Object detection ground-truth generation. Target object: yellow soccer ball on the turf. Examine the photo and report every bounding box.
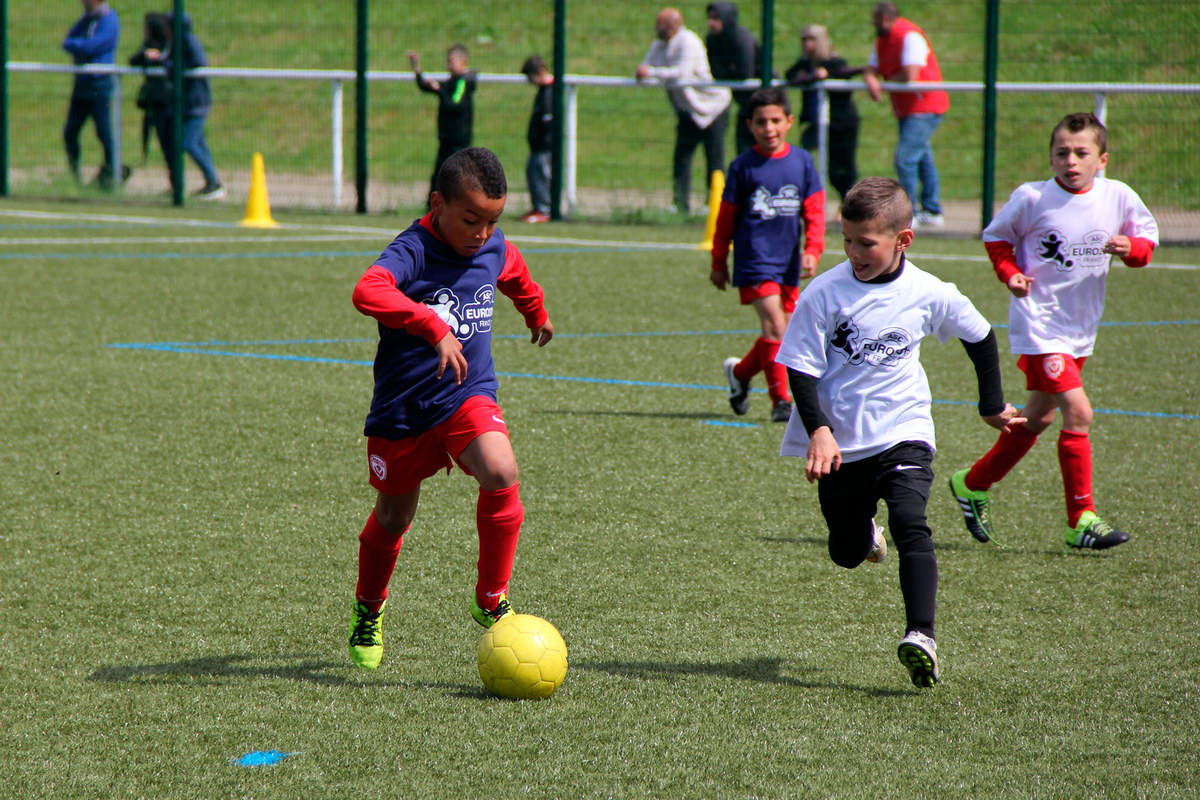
[475,614,566,700]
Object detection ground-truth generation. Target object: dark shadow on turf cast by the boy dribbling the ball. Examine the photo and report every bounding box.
[88,655,477,697]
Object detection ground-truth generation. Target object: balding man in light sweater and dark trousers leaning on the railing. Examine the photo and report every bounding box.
[634,7,730,213]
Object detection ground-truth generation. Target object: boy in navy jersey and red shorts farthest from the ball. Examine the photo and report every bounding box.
[709,86,826,422]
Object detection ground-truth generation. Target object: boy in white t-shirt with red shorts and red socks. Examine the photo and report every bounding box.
[950,113,1158,549]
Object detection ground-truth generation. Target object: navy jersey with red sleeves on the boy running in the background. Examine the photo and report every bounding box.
[721,145,824,287]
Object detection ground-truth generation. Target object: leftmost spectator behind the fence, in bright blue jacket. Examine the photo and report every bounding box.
[62,0,128,188]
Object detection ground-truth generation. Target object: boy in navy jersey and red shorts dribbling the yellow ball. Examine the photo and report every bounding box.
[349,148,554,669]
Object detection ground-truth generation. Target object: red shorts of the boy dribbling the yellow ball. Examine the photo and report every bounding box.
[367,396,509,494]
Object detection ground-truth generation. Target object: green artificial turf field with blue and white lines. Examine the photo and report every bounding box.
[0,201,1200,799]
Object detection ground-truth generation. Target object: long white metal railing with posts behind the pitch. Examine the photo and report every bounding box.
[8,61,1200,213]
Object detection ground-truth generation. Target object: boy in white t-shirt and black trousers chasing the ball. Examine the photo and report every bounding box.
[775,178,1024,687]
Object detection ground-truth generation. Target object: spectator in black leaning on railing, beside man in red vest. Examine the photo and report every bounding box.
[784,25,862,206]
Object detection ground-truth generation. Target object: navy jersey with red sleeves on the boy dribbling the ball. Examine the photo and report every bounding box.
[354,215,546,439]
